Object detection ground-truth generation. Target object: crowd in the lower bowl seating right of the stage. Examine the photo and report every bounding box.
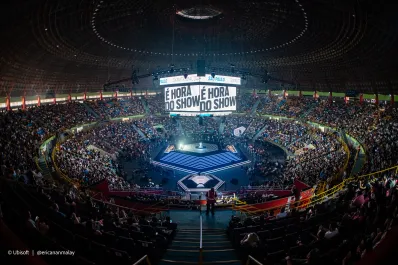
[236,118,347,187]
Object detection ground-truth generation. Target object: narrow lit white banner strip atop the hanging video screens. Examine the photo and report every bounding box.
[159,74,241,86]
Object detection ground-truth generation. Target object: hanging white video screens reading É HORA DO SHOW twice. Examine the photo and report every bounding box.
[164,85,236,112]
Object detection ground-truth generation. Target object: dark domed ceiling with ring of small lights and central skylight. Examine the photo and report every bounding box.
[0,0,398,95]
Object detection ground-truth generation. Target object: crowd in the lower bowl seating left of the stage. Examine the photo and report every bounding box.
[56,120,160,190]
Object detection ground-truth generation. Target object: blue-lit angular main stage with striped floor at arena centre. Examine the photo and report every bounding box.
[152,143,250,173]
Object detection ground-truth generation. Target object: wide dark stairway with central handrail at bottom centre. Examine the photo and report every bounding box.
[159,228,241,265]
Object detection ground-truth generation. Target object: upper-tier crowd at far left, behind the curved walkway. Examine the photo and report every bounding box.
[0,102,94,183]
